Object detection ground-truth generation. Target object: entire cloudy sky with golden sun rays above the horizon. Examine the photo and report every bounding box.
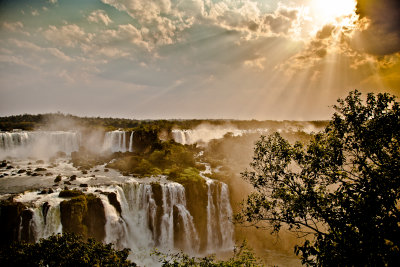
[0,0,400,120]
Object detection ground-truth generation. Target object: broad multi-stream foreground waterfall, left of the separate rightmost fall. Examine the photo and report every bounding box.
[101,183,199,253]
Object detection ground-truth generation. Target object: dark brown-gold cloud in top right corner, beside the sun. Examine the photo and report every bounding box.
[353,0,400,56]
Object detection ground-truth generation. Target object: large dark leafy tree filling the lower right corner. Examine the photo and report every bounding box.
[237,90,400,266]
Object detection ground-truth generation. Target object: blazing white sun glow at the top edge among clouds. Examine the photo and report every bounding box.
[310,0,357,24]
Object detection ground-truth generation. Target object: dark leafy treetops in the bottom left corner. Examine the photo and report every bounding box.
[0,233,136,266]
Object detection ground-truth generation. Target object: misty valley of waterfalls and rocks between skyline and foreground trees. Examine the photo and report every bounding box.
[0,114,326,266]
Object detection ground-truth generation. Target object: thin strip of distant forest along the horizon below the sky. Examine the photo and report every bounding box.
[0,113,327,131]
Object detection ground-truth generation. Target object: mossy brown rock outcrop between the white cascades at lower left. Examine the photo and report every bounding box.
[60,194,106,241]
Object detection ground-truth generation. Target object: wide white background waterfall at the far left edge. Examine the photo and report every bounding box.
[0,131,80,157]
